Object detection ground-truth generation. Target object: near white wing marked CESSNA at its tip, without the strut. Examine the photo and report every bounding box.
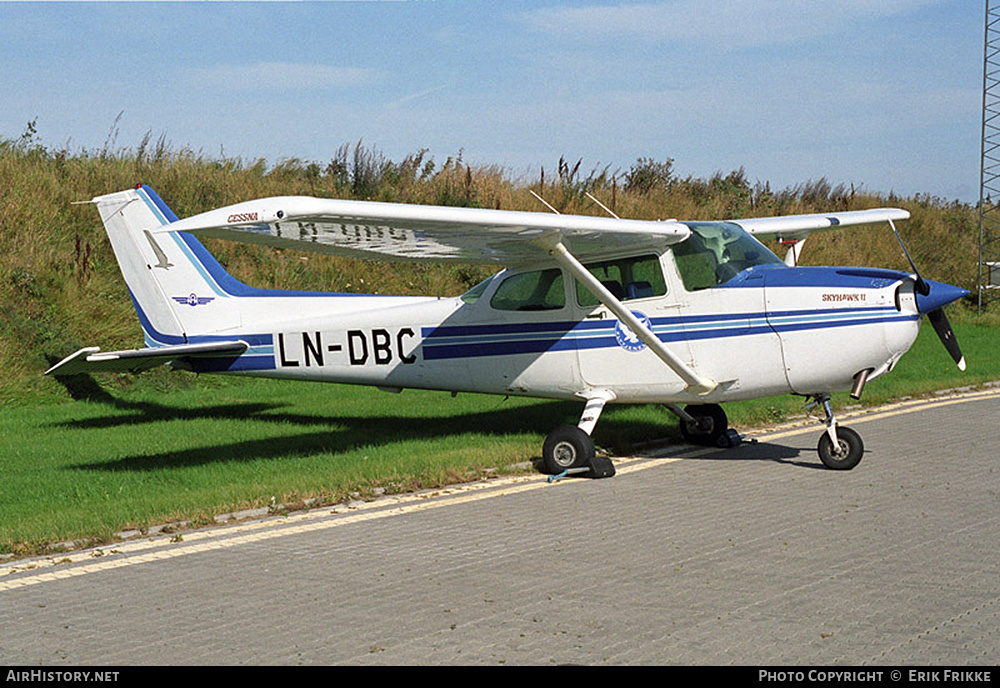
[156,196,690,265]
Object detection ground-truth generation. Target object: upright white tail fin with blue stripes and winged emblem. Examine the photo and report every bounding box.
[94,186,247,347]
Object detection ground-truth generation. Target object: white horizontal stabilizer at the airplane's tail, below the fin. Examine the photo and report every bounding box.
[45,341,249,375]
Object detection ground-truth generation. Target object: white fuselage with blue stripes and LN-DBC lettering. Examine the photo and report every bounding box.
[180,252,920,403]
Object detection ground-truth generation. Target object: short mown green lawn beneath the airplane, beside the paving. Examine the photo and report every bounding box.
[0,317,1000,554]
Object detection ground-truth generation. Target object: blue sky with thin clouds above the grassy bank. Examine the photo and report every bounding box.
[0,0,984,201]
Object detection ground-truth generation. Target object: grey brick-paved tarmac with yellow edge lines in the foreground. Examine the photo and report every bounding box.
[0,391,1000,666]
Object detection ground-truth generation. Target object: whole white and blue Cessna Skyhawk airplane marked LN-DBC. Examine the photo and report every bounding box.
[47,185,968,477]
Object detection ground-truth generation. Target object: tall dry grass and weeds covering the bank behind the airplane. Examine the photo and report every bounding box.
[0,129,977,404]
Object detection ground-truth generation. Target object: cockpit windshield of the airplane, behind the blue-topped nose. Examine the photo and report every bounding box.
[673,222,784,291]
